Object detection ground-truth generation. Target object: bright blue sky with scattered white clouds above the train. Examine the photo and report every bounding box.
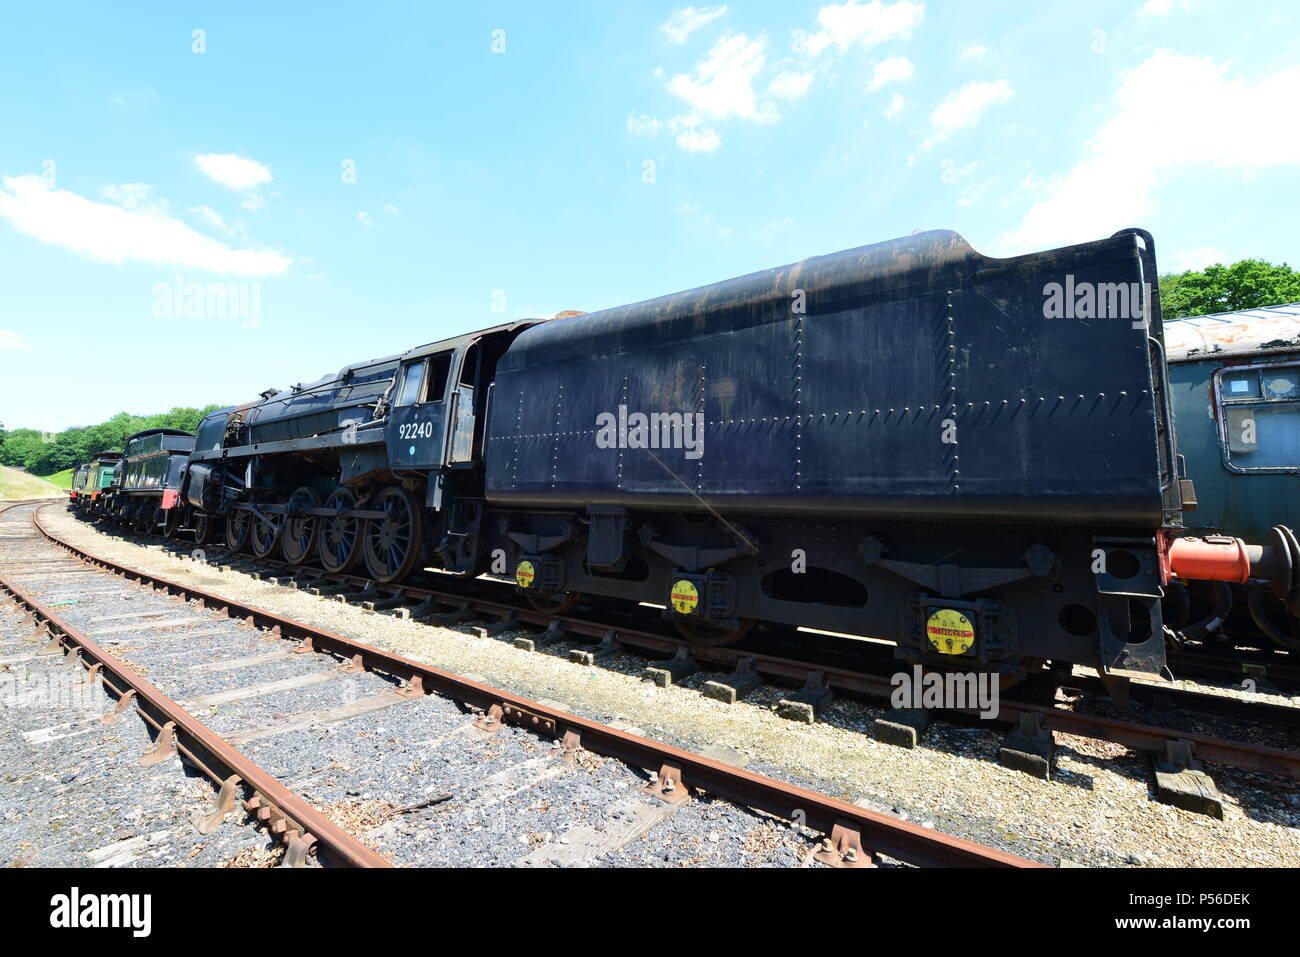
[0,0,1300,430]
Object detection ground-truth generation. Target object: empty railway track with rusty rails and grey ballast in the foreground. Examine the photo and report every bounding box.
[0,505,1032,866]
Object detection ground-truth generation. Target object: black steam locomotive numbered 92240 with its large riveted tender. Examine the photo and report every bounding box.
[76,230,1300,677]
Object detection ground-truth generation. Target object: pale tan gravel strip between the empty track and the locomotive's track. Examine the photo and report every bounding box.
[17,508,1300,867]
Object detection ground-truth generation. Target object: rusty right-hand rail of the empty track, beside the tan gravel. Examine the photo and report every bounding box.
[33,501,1044,867]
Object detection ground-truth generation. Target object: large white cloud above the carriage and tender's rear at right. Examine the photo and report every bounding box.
[1001,49,1300,251]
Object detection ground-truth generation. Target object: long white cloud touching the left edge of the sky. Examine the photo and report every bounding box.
[0,176,293,276]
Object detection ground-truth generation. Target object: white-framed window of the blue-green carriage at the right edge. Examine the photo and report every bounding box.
[1218,365,1300,472]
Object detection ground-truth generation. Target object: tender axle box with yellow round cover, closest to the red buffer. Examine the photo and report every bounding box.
[897,594,1019,663]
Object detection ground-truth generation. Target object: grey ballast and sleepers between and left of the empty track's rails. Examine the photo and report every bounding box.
[0,512,816,866]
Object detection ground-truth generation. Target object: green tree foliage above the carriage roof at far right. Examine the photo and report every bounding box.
[1160,259,1300,319]
